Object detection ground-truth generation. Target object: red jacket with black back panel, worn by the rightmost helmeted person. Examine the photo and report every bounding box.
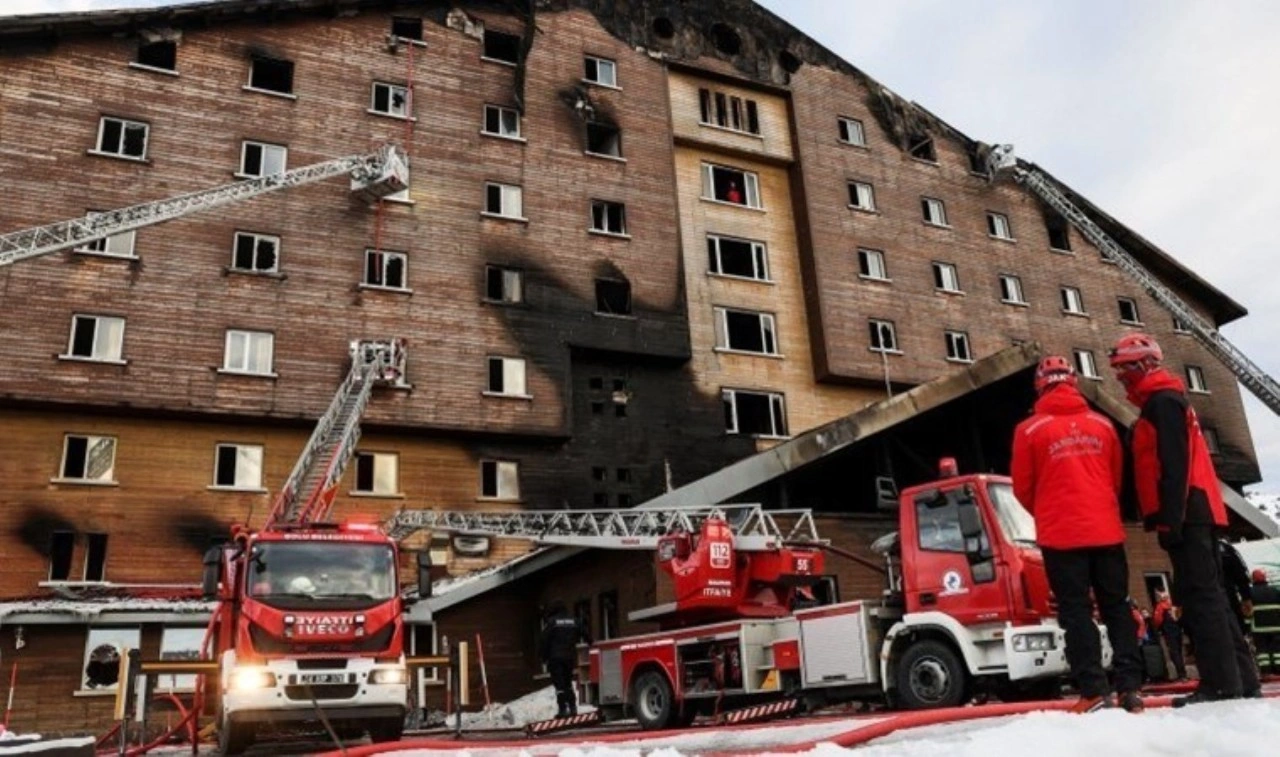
[1129,369,1226,534]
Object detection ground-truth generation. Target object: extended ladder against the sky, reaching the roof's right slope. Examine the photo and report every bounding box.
[987,145,1280,415]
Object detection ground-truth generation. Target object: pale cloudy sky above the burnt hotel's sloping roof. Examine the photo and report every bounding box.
[0,0,1280,492]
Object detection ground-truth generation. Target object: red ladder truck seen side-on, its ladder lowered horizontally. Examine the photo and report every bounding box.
[383,460,1095,730]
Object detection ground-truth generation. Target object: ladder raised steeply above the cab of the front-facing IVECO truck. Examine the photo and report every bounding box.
[266,339,404,529]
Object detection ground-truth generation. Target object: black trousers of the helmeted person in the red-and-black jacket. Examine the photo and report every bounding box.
[1167,523,1261,697]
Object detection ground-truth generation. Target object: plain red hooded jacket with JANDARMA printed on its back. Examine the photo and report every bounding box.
[1012,384,1124,549]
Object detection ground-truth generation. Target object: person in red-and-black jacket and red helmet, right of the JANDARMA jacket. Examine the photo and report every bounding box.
[1110,334,1261,707]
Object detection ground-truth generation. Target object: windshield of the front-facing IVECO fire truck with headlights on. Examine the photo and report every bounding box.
[248,542,396,608]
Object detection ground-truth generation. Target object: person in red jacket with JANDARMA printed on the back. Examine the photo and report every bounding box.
[1011,355,1142,712]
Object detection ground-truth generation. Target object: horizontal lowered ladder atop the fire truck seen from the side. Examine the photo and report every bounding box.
[383,505,823,552]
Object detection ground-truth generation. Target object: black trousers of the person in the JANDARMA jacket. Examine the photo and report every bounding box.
[1041,544,1143,697]
